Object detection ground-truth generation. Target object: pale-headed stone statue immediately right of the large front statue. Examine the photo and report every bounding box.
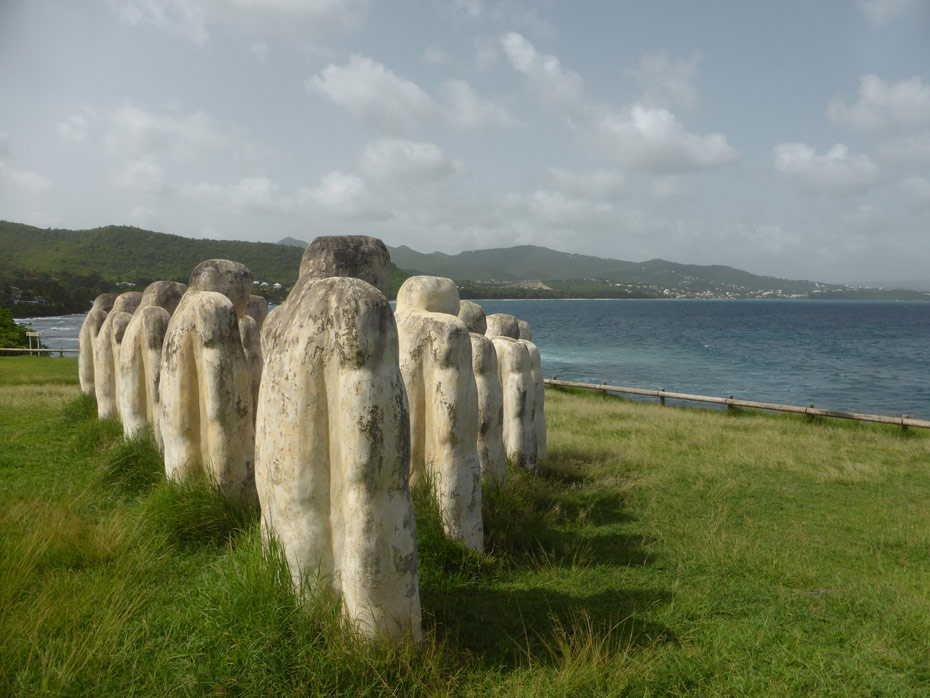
[394,276,484,550]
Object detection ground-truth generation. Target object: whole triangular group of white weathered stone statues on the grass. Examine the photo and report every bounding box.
[79,236,546,639]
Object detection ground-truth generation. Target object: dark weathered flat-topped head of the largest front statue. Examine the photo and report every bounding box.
[300,235,391,293]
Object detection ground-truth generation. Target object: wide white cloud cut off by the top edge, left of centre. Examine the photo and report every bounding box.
[108,0,370,45]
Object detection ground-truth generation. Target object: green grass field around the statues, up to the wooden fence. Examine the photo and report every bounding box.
[0,357,930,696]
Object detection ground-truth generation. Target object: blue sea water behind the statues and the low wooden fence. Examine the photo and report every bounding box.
[18,300,930,419]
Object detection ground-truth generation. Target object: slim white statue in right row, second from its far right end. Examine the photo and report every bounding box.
[487,314,539,472]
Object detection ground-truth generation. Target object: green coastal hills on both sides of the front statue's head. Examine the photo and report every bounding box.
[0,221,930,317]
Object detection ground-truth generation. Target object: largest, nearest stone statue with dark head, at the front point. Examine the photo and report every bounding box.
[255,236,421,640]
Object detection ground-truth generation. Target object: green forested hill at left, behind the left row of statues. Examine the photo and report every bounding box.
[0,221,303,286]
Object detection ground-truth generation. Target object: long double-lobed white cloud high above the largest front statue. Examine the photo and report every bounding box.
[306,54,516,135]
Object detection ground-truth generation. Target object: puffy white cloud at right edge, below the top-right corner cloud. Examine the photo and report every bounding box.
[827,75,930,131]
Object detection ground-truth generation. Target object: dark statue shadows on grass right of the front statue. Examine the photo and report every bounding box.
[421,454,676,669]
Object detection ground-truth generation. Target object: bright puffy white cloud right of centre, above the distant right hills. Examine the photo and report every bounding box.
[578,104,737,174]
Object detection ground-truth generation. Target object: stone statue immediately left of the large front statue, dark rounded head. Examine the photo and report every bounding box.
[158,259,255,501]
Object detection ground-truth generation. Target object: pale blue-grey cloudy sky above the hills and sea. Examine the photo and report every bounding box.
[0,0,930,283]
